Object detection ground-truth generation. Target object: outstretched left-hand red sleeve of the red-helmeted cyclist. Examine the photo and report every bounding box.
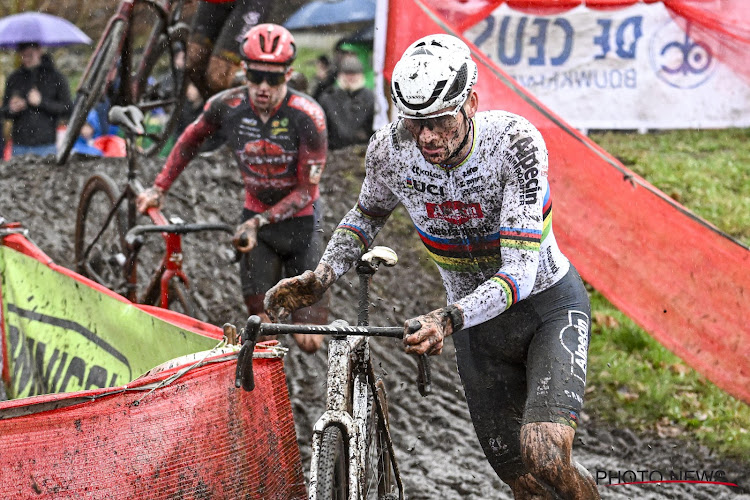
[154,100,220,192]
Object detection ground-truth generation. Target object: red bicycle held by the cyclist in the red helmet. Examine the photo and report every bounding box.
[74,106,236,317]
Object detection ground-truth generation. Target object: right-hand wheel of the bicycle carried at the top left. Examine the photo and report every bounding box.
[128,2,187,156]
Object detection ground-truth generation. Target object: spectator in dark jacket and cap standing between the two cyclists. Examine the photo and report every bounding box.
[318,55,375,149]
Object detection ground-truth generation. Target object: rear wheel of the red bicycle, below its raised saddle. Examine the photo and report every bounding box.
[74,174,127,294]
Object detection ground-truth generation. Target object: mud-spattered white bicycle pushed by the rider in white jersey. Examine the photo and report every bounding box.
[235,246,430,500]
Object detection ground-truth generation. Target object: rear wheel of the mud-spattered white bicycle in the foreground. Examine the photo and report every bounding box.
[362,380,398,500]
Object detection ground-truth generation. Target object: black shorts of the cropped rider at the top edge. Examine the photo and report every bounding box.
[190,0,271,64]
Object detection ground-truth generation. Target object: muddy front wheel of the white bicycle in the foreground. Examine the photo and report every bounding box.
[315,426,349,500]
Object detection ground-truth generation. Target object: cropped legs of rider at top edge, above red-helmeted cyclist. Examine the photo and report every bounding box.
[186,0,271,99]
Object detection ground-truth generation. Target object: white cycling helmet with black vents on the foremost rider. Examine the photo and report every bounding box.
[391,34,477,119]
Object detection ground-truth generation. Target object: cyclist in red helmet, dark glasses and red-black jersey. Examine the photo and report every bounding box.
[137,24,328,352]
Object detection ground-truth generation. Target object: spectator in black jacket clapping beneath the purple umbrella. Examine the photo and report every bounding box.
[2,43,72,156]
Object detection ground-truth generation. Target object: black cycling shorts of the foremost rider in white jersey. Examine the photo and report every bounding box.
[453,266,591,479]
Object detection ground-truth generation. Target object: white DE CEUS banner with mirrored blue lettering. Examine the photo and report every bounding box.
[464,2,750,131]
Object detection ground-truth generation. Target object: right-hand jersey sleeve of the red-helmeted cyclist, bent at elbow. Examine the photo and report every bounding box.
[266,95,328,222]
